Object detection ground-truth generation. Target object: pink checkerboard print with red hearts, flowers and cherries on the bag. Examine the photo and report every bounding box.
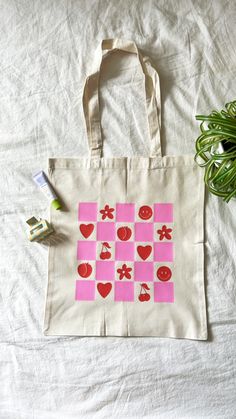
[75,202,174,303]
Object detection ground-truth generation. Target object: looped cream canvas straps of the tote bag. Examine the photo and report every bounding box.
[83,39,161,157]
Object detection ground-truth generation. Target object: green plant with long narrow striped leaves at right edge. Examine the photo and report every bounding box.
[195,101,236,202]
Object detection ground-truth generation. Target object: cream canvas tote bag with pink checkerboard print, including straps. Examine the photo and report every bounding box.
[43,39,207,340]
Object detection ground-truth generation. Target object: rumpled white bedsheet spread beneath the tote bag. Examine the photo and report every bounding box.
[0,0,236,419]
